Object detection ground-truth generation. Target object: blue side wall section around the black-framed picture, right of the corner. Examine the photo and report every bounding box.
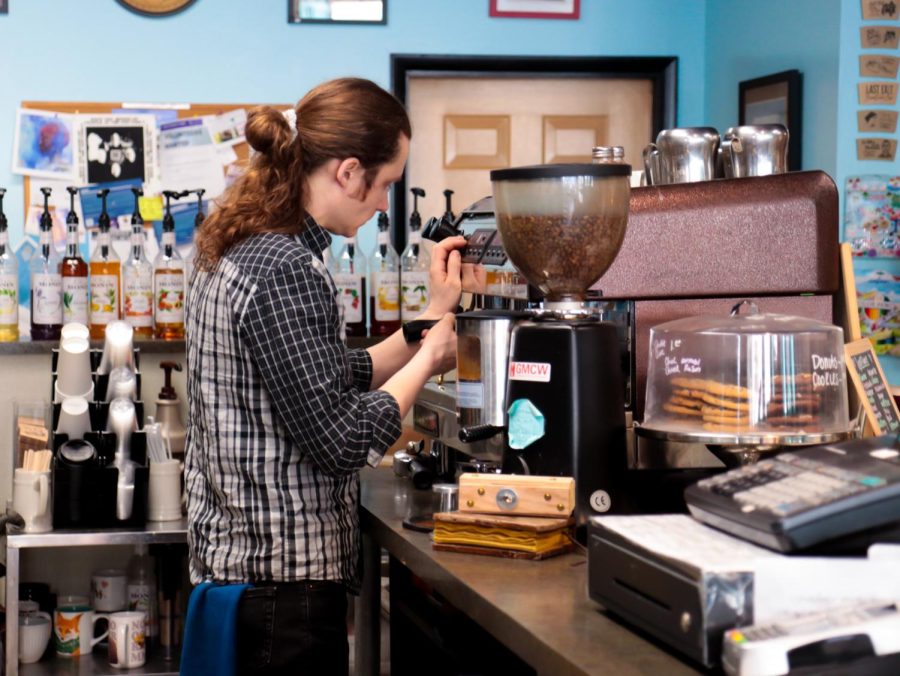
[706,0,844,176]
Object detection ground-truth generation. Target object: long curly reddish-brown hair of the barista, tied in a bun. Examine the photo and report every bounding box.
[195,78,412,270]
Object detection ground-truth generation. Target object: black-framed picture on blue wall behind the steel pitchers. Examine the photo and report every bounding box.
[738,70,803,171]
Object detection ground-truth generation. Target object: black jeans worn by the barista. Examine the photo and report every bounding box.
[237,581,349,676]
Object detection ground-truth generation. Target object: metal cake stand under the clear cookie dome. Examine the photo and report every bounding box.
[634,423,850,467]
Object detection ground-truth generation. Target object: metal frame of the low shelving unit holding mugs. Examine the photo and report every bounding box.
[6,519,187,676]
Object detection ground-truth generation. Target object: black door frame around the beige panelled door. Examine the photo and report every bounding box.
[391,54,678,251]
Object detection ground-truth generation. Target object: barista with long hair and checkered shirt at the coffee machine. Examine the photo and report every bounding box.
[185,78,464,674]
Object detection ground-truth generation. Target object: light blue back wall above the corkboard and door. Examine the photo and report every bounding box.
[0,0,706,251]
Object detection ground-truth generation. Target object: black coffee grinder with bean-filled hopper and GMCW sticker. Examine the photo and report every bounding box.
[457,164,631,527]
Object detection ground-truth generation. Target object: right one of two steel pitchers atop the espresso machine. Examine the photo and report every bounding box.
[722,124,790,178]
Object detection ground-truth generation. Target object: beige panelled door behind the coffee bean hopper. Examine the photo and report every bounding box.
[407,77,652,220]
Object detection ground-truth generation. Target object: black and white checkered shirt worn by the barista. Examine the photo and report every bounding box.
[185,219,400,589]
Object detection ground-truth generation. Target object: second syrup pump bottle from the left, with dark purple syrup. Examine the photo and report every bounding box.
[31,188,62,340]
